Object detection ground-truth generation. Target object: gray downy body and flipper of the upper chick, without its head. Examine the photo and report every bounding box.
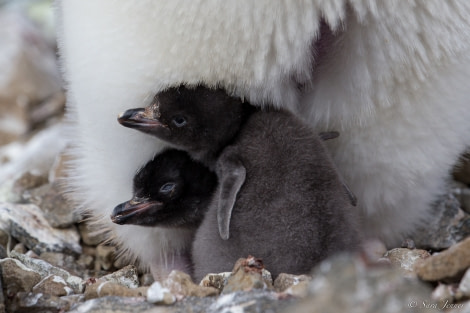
[193,112,359,279]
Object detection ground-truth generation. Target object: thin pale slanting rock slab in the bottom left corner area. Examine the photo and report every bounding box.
[11,252,85,294]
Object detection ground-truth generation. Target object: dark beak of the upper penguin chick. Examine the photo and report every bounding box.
[118,108,169,136]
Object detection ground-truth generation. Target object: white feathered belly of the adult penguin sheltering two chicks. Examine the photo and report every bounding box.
[57,0,470,276]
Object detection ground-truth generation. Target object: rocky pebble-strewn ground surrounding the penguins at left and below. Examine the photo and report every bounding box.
[0,1,470,313]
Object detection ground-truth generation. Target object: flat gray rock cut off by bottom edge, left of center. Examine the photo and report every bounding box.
[69,296,155,313]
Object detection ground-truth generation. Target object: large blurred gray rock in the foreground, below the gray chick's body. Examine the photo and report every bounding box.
[283,254,432,313]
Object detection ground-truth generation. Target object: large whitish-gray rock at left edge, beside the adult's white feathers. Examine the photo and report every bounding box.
[0,203,82,254]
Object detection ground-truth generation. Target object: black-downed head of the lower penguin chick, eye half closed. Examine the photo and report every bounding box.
[111,149,217,229]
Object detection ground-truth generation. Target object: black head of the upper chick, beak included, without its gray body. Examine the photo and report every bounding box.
[118,85,255,169]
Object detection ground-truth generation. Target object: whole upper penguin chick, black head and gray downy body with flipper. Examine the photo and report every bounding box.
[116,86,360,280]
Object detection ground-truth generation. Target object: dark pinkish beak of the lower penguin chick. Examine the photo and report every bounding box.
[111,199,163,226]
